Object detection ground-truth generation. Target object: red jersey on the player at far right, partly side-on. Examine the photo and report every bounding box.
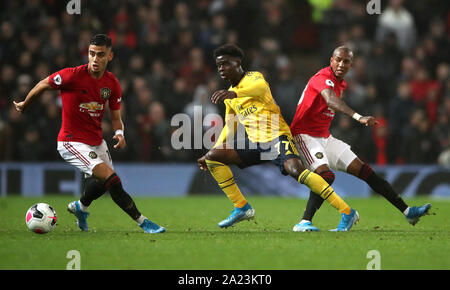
[291,67,347,137]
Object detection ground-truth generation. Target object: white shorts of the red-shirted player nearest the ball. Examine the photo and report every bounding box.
[58,140,114,177]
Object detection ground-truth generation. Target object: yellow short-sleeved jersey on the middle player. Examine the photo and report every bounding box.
[215,71,292,147]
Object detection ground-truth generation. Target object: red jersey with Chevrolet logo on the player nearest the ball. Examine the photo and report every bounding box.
[49,64,122,146]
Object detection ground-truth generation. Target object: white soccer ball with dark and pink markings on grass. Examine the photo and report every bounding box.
[25,202,57,234]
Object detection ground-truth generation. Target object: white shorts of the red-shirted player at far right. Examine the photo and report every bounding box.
[294,134,357,171]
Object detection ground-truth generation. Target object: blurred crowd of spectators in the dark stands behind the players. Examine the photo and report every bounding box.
[0,0,450,165]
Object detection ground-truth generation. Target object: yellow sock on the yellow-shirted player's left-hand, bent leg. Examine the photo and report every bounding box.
[206,159,247,208]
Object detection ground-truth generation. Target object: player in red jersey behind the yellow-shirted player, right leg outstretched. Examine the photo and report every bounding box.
[290,46,431,232]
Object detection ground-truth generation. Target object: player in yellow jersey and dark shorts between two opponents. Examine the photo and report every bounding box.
[198,44,359,231]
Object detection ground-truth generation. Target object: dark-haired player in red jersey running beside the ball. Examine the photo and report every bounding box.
[14,34,165,233]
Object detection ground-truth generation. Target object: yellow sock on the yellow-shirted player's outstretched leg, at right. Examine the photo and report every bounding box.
[298,169,351,214]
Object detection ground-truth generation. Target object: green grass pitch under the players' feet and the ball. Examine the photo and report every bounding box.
[0,195,450,270]
